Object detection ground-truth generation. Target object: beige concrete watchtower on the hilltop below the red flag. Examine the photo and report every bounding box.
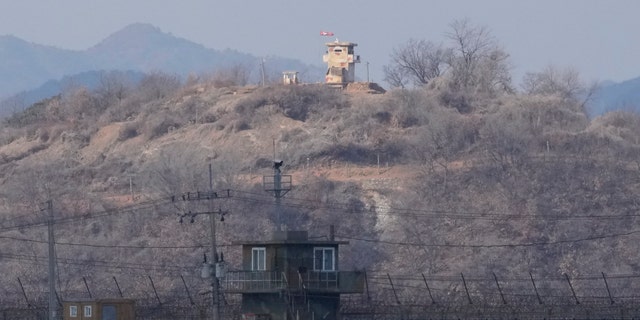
[322,40,360,86]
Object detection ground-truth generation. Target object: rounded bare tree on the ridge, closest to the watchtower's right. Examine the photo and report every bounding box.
[384,39,450,87]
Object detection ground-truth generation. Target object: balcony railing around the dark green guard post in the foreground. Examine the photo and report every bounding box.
[220,271,364,293]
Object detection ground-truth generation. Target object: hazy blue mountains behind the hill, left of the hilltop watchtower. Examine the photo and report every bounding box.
[0,23,325,111]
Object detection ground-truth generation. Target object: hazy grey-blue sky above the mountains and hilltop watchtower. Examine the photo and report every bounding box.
[0,0,640,83]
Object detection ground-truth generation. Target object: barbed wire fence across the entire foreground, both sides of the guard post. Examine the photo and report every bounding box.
[0,272,640,320]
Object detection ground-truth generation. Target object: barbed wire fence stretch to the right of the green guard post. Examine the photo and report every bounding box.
[342,273,640,320]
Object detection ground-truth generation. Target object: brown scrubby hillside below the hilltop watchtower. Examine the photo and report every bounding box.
[0,83,640,304]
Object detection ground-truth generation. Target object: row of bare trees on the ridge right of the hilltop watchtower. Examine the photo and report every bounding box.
[384,19,598,111]
